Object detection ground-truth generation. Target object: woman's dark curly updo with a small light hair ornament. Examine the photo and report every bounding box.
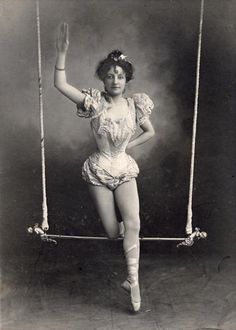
[96,50,134,82]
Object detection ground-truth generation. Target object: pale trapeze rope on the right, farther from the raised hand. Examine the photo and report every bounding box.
[185,0,204,234]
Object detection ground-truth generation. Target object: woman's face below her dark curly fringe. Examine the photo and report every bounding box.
[104,65,126,96]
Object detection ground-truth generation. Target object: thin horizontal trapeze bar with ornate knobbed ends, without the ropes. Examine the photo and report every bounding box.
[27,224,207,247]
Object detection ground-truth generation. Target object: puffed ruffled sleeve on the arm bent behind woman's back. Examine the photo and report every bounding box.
[133,93,154,125]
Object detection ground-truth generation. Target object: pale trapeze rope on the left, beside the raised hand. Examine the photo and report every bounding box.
[36,0,48,230]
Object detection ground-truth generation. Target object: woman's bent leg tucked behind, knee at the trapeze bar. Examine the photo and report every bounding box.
[89,184,119,238]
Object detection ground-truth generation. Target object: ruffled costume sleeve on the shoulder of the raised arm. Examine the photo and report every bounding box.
[76,88,101,118]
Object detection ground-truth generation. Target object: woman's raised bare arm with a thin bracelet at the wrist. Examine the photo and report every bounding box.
[54,23,85,106]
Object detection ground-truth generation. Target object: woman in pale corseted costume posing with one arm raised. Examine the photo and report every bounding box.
[54,23,155,312]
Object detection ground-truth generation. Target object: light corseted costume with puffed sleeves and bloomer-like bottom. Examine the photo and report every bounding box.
[77,88,154,190]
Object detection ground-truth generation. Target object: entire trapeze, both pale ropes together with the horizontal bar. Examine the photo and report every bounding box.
[27,0,207,247]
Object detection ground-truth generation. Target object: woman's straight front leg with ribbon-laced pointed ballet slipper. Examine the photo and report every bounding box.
[114,179,141,311]
